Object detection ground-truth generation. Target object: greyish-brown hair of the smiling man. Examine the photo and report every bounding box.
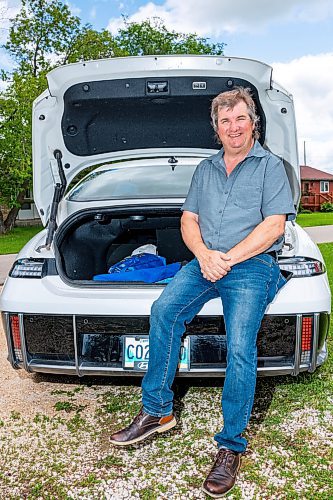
[211,87,260,142]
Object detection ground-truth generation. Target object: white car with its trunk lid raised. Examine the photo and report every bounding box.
[0,56,331,376]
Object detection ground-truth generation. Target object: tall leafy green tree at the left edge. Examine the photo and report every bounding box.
[0,0,83,234]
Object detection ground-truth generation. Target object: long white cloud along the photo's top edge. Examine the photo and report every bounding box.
[108,0,333,36]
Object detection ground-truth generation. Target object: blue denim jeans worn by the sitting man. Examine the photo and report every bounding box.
[142,254,286,452]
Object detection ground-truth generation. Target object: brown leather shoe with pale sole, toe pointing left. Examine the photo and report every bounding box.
[110,409,177,446]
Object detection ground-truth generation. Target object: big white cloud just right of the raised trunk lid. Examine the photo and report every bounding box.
[272,52,333,173]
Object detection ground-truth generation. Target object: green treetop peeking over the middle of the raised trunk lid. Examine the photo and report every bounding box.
[115,17,225,56]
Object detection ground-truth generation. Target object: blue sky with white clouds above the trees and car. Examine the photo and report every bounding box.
[0,0,333,174]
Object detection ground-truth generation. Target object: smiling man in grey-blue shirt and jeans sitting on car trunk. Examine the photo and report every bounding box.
[111,88,295,498]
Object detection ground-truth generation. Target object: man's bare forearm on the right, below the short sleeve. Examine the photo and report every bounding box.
[227,216,285,266]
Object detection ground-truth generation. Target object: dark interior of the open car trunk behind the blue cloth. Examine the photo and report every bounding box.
[55,207,193,286]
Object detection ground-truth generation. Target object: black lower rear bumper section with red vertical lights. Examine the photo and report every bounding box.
[3,312,329,377]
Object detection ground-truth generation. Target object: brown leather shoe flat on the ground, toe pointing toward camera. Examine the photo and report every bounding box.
[202,448,241,498]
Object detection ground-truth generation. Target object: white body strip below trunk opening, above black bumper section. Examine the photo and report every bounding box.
[1,275,330,316]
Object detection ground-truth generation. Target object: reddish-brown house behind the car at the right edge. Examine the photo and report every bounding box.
[301,166,333,212]
